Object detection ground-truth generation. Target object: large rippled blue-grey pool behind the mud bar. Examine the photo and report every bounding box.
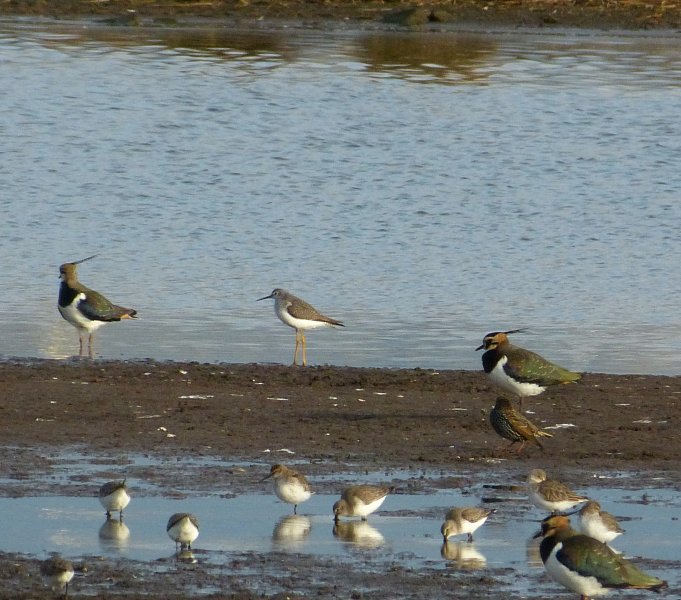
[0,22,681,374]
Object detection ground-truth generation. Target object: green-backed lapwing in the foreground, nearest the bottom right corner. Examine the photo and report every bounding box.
[537,515,667,600]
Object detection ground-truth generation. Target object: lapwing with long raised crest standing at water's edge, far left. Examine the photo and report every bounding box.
[58,255,137,358]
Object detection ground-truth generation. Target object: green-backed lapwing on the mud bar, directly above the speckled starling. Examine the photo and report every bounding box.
[476,329,582,410]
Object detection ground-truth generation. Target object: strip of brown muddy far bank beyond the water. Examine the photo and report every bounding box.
[0,0,681,31]
